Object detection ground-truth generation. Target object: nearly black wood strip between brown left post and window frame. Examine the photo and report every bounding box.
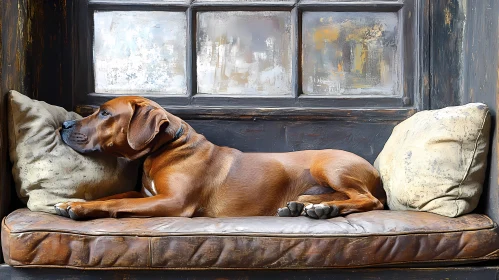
[26,0,73,109]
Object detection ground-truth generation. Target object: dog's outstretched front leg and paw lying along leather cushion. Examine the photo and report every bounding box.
[55,195,195,220]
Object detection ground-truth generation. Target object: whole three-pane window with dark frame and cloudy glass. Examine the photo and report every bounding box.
[75,0,427,118]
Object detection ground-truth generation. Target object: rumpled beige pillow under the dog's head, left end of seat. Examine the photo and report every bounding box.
[8,91,138,213]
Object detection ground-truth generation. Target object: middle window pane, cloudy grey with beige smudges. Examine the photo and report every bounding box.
[197,11,292,95]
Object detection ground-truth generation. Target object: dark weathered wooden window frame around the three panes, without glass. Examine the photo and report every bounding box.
[73,0,429,120]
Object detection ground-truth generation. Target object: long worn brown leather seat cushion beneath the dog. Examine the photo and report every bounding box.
[2,209,499,269]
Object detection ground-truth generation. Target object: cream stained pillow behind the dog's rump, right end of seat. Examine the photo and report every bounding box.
[374,103,490,217]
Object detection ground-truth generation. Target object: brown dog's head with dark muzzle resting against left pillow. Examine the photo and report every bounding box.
[61,96,181,159]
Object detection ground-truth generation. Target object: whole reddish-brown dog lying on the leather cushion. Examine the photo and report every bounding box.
[55,96,385,219]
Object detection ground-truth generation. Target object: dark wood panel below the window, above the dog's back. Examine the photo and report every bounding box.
[186,120,398,163]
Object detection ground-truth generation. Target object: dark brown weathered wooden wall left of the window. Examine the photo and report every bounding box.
[0,0,72,230]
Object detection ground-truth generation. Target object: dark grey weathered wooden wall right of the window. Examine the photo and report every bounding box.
[430,0,499,222]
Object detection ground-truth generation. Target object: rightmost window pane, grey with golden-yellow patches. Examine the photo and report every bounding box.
[302,12,400,96]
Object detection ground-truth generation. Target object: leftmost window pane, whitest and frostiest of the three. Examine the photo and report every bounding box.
[94,11,187,94]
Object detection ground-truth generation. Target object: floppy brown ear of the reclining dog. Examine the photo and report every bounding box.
[127,102,168,151]
